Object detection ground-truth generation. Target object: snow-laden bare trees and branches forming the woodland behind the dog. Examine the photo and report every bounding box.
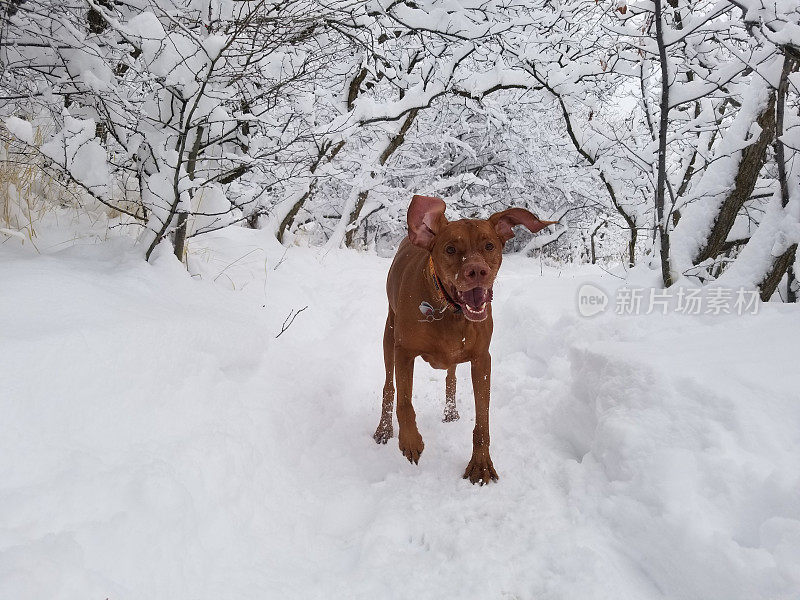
[0,0,800,297]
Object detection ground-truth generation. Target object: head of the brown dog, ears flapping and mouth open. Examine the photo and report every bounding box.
[408,195,557,321]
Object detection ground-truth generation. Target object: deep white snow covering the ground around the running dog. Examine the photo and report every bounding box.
[0,229,800,600]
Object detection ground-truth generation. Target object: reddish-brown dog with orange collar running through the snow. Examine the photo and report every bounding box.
[373,196,556,484]
